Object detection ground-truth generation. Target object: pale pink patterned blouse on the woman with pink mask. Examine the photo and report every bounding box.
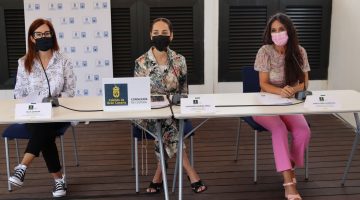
[255,45,310,88]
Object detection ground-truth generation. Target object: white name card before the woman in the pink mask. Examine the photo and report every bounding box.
[304,94,341,110]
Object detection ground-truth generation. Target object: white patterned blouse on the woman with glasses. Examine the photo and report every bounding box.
[14,51,75,99]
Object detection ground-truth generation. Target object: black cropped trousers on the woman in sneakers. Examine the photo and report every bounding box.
[25,122,70,173]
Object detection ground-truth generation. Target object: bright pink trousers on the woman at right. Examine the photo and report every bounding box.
[253,115,311,172]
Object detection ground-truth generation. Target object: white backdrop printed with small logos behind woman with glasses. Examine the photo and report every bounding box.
[24,0,113,96]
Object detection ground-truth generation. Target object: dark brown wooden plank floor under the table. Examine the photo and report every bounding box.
[0,115,360,200]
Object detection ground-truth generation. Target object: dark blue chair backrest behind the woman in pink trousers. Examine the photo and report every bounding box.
[241,66,260,93]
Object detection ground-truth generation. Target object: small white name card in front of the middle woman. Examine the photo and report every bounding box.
[180,95,215,114]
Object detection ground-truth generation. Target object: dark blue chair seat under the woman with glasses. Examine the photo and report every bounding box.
[2,123,70,139]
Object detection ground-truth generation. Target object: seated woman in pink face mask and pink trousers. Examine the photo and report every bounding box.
[253,13,310,200]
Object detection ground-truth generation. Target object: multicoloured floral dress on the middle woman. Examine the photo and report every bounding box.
[134,48,188,158]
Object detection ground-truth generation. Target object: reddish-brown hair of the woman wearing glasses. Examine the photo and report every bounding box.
[25,19,59,73]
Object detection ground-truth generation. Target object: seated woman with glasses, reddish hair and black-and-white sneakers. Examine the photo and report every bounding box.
[9,19,75,197]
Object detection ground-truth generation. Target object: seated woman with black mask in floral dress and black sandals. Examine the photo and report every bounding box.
[134,18,207,193]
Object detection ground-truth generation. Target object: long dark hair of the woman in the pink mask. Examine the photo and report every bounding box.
[264,13,305,85]
